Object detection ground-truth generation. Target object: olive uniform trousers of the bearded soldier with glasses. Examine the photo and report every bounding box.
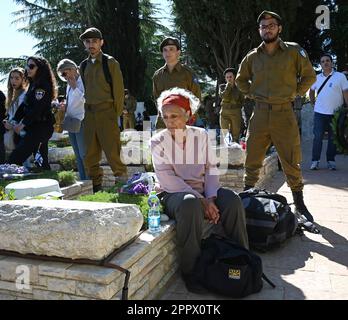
[244,102,303,191]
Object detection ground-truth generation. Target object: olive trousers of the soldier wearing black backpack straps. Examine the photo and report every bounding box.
[84,102,127,186]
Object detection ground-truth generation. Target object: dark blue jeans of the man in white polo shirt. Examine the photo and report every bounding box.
[312,112,336,161]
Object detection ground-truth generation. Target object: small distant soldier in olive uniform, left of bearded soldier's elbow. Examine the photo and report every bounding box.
[219,68,244,142]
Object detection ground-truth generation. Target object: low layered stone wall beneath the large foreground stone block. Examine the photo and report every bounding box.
[0,221,178,300]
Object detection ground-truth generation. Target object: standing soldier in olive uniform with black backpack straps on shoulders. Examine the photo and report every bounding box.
[80,28,127,192]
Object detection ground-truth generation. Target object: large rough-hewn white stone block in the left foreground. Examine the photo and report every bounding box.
[0,200,143,260]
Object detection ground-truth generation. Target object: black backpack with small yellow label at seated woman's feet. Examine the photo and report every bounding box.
[194,235,275,298]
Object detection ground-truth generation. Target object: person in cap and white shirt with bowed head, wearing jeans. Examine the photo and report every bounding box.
[57,59,88,180]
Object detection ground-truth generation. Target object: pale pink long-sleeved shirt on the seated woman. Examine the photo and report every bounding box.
[150,126,220,198]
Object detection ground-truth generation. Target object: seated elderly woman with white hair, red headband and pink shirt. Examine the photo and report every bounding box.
[151,88,248,292]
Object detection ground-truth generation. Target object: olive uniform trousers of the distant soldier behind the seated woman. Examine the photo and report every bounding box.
[220,106,242,142]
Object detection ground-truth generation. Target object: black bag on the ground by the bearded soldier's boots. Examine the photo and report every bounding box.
[239,189,299,251]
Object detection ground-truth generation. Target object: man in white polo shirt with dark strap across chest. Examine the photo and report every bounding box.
[309,54,348,170]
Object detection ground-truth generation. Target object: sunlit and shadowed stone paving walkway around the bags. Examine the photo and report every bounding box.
[159,141,348,300]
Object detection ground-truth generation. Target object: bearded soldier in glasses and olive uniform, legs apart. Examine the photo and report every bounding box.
[236,11,316,221]
